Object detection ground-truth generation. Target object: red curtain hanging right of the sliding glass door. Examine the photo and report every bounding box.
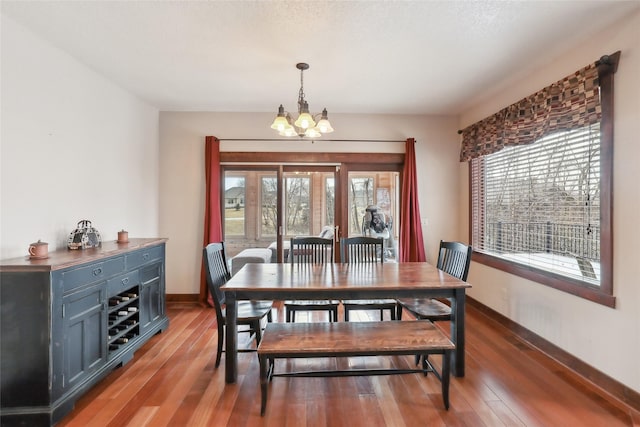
[399,138,427,262]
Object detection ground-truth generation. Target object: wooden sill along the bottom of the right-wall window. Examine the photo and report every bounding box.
[471,251,616,308]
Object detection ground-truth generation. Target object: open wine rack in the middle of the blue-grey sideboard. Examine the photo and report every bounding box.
[108,286,140,357]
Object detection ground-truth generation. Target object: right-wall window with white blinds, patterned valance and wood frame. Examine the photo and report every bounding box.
[468,53,619,307]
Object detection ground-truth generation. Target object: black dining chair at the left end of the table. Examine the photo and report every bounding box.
[203,242,273,368]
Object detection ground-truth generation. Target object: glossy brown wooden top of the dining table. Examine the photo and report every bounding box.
[222,262,471,291]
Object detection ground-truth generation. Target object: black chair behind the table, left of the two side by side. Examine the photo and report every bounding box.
[284,237,340,322]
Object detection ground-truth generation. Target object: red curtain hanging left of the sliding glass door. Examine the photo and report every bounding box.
[199,136,222,306]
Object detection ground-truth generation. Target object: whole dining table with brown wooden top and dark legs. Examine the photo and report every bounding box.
[221,262,471,383]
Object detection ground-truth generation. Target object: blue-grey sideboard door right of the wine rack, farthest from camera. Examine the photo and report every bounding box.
[140,262,164,331]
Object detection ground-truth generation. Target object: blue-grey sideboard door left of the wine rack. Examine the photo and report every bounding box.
[62,282,107,390]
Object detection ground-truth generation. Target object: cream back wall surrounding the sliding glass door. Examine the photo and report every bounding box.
[160,112,460,294]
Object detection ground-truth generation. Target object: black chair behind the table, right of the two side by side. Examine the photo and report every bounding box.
[340,236,398,322]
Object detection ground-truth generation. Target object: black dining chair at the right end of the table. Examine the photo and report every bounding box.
[396,240,473,322]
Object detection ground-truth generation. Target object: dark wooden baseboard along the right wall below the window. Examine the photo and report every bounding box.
[467,296,640,419]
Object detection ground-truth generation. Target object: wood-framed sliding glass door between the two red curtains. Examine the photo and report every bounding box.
[222,160,400,262]
